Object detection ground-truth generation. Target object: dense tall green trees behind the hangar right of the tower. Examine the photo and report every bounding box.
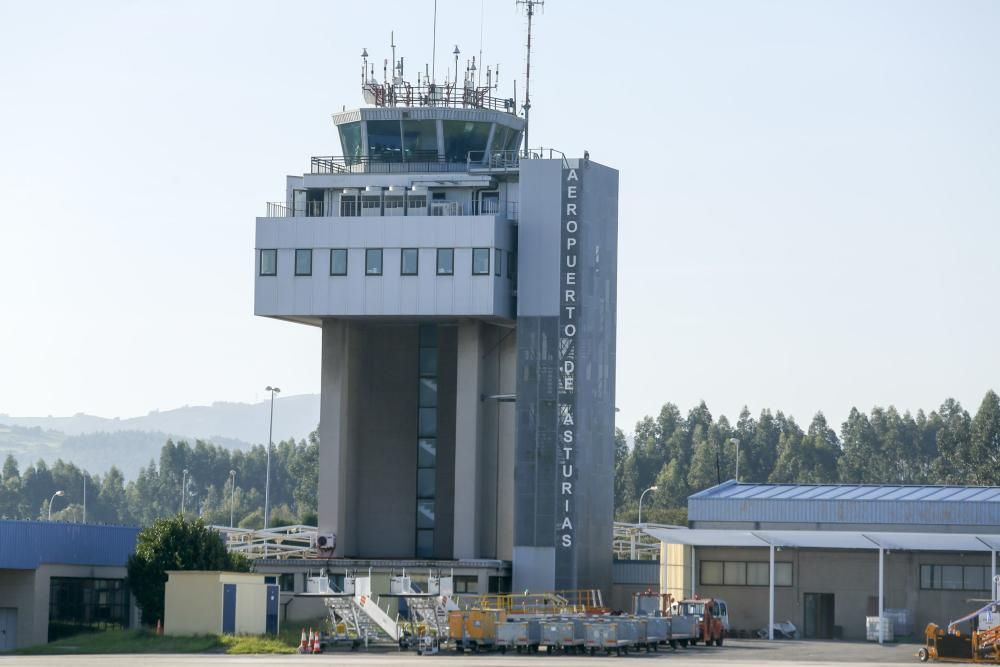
[614,390,1000,523]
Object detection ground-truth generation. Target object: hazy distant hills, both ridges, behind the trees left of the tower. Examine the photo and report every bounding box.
[0,394,319,479]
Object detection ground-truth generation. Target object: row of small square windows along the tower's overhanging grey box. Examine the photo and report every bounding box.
[260,248,514,278]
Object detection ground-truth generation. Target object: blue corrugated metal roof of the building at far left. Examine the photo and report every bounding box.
[0,520,139,570]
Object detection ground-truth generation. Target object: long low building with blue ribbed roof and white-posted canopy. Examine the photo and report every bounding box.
[645,481,1000,639]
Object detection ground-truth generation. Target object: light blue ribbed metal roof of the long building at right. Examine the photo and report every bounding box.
[688,480,1000,533]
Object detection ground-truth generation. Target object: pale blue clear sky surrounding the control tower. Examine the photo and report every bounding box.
[0,0,1000,432]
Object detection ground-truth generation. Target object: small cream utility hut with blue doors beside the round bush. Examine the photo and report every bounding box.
[163,570,280,635]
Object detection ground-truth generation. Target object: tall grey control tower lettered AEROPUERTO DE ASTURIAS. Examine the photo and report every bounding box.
[254,28,618,594]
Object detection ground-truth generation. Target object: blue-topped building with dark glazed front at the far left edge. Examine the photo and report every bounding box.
[0,521,139,651]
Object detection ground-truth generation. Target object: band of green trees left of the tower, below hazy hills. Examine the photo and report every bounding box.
[0,431,319,528]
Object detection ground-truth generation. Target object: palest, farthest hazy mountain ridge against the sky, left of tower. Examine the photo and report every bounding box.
[0,394,319,448]
